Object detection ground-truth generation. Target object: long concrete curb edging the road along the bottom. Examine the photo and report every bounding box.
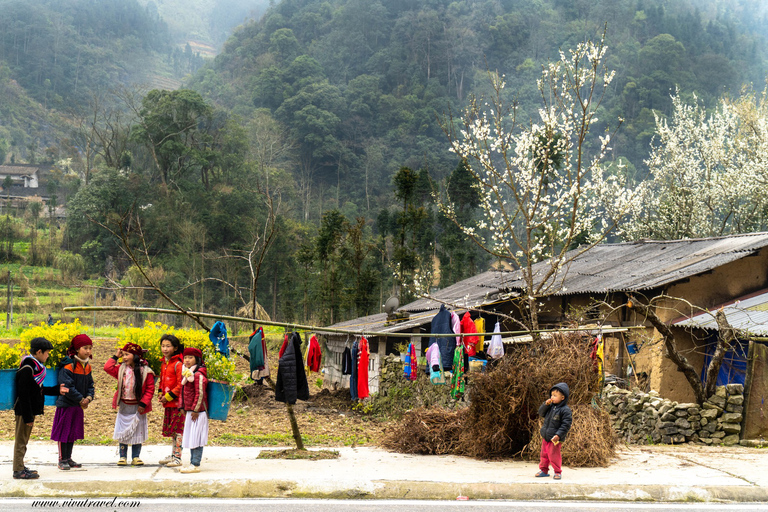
[0,479,768,503]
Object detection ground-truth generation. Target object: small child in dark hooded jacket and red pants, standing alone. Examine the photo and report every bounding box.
[536,382,573,480]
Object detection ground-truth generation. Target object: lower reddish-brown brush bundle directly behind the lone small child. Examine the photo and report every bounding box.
[523,405,616,468]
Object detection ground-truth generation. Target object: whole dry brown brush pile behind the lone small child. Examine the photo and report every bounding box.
[384,333,615,467]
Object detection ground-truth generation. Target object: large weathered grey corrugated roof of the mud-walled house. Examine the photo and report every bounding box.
[332,233,768,332]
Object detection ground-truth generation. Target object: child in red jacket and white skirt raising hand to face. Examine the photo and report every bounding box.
[104,343,155,466]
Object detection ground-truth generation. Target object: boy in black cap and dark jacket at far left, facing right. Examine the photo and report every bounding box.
[13,338,69,480]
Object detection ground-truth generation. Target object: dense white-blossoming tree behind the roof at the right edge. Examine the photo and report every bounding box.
[622,90,768,240]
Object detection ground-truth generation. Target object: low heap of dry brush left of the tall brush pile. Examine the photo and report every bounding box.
[383,407,462,455]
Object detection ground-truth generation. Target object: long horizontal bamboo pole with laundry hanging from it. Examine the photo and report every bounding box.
[64,306,647,338]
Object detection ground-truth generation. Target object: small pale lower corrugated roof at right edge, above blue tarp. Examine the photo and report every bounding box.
[673,290,768,336]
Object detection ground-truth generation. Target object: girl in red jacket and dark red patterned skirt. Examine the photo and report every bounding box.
[157,334,184,468]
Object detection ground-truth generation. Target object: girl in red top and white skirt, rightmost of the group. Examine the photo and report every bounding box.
[179,347,208,473]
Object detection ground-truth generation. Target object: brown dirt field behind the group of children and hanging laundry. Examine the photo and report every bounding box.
[0,338,386,446]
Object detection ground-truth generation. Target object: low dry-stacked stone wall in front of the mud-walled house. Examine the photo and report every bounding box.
[603,384,744,446]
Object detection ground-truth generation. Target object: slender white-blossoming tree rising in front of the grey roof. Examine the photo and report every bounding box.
[441,33,633,329]
